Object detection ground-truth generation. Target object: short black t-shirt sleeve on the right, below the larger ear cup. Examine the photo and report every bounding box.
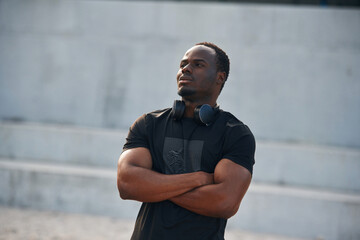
[223,125,256,174]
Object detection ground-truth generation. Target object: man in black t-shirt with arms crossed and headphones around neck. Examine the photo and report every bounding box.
[117,42,255,240]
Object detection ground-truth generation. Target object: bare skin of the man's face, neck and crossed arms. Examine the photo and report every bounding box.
[117,45,251,219]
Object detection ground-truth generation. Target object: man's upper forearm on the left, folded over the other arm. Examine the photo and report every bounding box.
[118,166,210,202]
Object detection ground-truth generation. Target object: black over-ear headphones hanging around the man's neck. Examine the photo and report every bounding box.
[171,100,219,126]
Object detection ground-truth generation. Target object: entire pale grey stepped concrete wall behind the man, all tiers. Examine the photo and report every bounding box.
[0,0,360,240]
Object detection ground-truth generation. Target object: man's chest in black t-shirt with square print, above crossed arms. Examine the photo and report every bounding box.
[148,119,223,174]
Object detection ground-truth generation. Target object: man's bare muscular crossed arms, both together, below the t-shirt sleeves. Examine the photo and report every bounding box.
[117,148,251,218]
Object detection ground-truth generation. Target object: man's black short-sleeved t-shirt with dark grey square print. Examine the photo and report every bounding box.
[124,109,255,240]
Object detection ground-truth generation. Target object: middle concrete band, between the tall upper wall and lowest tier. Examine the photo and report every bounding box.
[0,123,360,191]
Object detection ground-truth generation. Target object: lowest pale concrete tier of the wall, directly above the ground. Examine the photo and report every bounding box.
[0,159,360,240]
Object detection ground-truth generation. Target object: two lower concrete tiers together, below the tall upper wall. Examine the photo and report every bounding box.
[0,123,360,240]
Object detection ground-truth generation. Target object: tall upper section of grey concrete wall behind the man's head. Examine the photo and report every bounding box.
[0,0,360,148]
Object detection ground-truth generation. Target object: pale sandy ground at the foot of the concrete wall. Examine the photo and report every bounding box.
[0,206,305,240]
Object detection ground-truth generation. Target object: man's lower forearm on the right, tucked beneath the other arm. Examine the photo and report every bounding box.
[170,183,239,219]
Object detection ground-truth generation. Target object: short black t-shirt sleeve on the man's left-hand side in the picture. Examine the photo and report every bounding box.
[123,114,149,151]
